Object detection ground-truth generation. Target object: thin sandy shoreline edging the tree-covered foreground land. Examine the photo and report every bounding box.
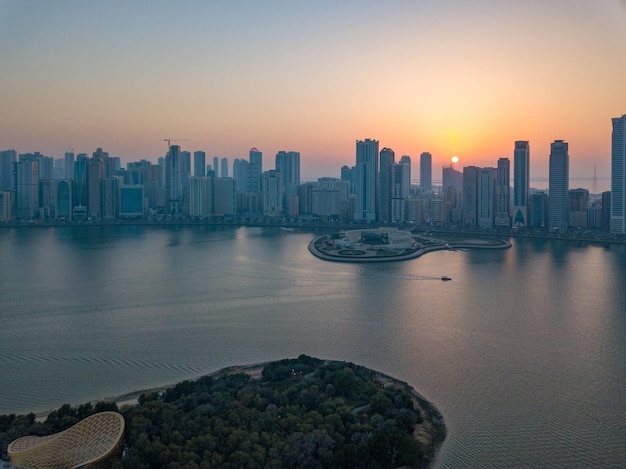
[34,360,447,467]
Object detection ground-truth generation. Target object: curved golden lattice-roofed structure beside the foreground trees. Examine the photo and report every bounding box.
[7,412,124,469]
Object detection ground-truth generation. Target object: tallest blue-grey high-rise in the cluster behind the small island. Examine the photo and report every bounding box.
[354,138,378,221]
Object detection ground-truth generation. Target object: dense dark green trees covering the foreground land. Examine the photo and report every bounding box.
[0,355,434,469]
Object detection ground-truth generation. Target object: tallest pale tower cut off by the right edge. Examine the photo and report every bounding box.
[610,114,626,233]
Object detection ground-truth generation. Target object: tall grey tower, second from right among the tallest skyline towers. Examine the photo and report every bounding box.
[548,140,569,231]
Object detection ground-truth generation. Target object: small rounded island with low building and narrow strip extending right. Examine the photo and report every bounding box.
[309,227,511,264]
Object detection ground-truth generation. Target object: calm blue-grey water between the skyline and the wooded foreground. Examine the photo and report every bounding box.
[0,227,626,468]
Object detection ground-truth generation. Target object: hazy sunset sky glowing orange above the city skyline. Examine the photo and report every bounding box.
[0,0,626,187]
